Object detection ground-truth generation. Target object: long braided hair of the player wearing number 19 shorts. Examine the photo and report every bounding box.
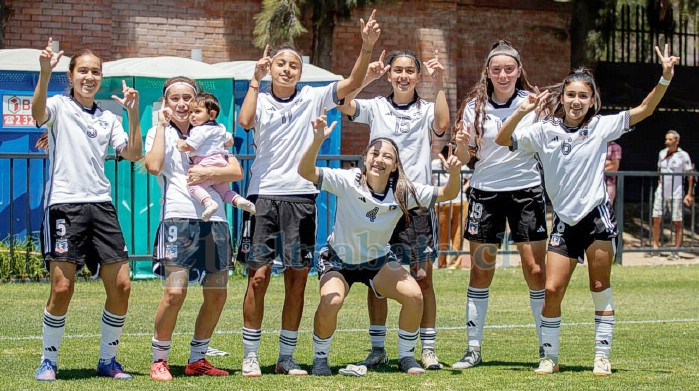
[456,40,534,152]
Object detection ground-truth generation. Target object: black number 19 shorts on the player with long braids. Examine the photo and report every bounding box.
[464,186,548,245]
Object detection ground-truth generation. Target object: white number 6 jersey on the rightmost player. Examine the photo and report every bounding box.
[512,111,631,225]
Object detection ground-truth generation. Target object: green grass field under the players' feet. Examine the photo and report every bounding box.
[0,265,699,390]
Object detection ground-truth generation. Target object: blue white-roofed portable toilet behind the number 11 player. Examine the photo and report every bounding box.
[213,61,343,258]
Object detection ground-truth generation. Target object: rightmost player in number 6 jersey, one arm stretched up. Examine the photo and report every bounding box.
[495,45,679,376]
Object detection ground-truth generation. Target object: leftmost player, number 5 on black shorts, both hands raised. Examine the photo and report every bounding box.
[32,38,141,381]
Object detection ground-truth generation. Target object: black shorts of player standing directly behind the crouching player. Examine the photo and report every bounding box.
[389,208,437,269]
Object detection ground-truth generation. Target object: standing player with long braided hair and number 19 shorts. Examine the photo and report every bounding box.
[452,41,546,369]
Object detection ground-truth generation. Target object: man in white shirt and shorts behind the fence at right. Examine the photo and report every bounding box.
[653,130,694,260]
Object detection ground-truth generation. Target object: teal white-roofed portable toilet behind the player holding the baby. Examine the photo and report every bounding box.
[97,56,239,279]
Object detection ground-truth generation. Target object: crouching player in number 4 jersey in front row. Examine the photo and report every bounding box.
[298,115,461,376]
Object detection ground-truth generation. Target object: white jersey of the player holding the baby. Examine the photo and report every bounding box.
[146,125,226,221]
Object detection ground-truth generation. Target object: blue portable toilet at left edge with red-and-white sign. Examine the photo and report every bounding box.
[0,49,70,243]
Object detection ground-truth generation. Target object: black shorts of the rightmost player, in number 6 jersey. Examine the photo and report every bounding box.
[548,202,618,263]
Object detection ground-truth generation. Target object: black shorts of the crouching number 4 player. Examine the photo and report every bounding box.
[318,247,397,299]
